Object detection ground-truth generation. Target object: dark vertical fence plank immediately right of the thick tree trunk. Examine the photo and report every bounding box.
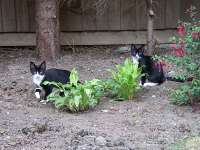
[60,0,82,31]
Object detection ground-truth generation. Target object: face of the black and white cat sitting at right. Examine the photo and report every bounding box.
[131,44,144,63]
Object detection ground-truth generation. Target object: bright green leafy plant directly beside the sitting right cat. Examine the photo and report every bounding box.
[106,59,141,100]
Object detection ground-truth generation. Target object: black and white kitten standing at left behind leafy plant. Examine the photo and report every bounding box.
[30,61,70,100]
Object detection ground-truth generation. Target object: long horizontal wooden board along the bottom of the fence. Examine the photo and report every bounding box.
[0,30,175,46]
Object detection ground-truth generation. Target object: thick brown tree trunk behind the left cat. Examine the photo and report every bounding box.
[35,0,60,61]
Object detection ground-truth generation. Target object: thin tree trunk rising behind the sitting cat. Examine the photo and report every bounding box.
[146,0,155,55]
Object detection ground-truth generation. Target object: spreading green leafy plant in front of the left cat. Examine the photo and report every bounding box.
[43,69,104,112]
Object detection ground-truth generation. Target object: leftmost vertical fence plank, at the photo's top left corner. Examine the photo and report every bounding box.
[1,0,17,32]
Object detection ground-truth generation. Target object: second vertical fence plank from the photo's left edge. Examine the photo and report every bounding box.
[15,0,29,32]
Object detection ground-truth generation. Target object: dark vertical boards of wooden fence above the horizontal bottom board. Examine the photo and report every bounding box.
[0,0,200,45]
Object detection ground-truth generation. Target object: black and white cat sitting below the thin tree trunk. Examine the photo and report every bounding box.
[131,45,184,87]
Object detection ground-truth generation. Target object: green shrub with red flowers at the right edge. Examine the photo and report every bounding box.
[164,6,200,105]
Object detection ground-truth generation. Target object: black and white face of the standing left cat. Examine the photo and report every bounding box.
[30,61,46,87]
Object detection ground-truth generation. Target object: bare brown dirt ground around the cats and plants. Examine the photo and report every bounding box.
[0,47,200,150]
